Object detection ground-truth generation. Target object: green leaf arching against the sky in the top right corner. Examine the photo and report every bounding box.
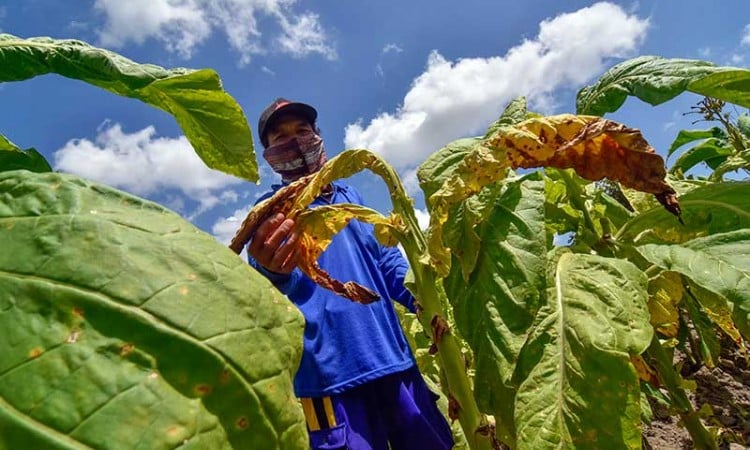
[576,56,750,116]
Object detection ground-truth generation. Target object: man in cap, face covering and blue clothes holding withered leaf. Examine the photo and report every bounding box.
[248,98,453,450]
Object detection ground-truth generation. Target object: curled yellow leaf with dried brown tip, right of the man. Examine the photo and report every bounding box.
[428,114,680,275]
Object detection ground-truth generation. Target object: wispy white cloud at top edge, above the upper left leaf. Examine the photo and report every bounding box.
[94,0,336,65]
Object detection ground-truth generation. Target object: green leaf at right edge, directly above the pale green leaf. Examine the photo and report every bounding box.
[617,181,750,244]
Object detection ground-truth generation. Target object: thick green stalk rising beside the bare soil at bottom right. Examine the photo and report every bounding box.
[647,334,719,450]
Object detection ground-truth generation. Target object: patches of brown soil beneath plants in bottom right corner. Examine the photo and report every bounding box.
[643,341,750,450]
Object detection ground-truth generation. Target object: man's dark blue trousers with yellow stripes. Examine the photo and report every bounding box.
[300,367,453,450]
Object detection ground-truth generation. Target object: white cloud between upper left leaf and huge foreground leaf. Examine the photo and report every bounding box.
[54,123,242,218]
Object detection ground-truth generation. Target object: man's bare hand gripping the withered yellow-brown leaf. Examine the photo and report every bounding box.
[247,213,299,274]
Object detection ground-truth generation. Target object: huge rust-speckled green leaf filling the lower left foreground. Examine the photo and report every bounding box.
[0,171,308,449]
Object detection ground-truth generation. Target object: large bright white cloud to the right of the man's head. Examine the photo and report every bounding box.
[344,3,649,168]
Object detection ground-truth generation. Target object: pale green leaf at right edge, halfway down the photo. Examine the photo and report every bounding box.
[637,228,750,340]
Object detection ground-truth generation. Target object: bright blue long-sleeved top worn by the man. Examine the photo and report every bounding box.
[249,182,414,397]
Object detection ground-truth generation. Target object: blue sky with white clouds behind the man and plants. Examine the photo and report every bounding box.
[0,0,750,248]
